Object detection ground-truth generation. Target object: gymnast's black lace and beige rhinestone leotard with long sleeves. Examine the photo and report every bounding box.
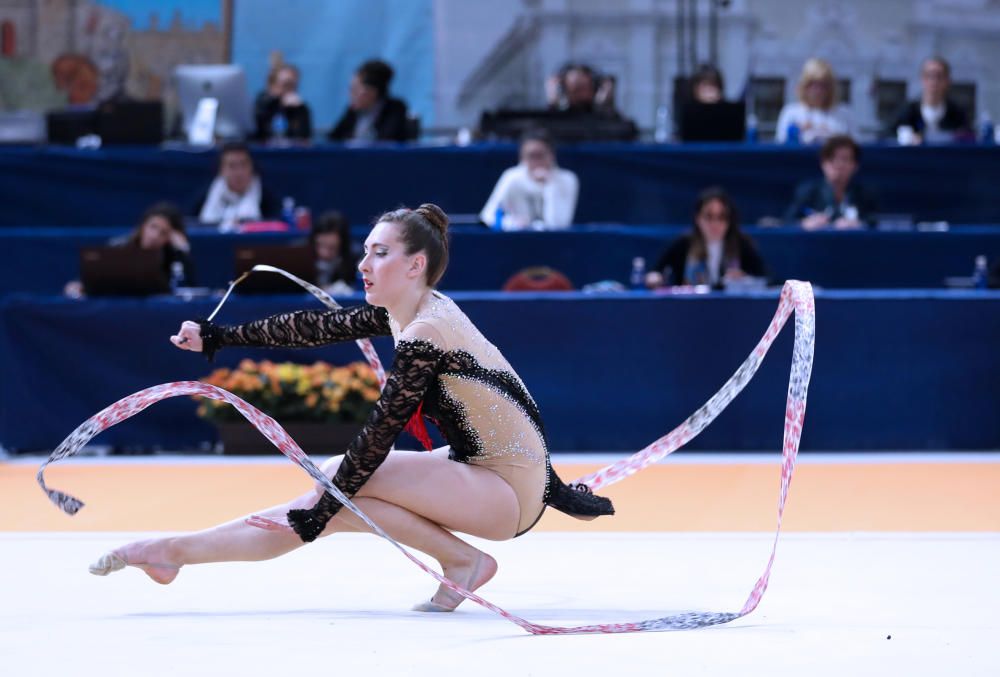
[201,292,614,541]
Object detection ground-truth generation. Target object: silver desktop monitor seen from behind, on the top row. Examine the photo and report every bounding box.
[174,64,253,139]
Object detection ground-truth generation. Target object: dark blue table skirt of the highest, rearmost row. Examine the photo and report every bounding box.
[0,144,1000,226]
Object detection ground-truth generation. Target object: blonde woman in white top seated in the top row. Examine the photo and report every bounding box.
[775,59,852,143]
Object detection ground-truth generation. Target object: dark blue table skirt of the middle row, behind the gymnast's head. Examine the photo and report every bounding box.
[0,226,1000,294]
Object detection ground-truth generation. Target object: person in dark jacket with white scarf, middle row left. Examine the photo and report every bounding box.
[194,141,281,227]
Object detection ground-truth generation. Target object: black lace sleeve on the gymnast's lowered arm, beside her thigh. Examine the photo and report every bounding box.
[288,339,444,542]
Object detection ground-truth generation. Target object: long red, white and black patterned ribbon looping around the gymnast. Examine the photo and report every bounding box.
[37,281,816,635]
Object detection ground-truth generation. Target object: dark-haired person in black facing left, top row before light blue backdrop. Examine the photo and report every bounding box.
[328,59,409,141]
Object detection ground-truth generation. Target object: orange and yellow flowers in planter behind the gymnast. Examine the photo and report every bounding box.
[195,360,379,455]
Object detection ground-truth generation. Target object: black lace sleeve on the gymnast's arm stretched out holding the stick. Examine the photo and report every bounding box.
[199,305,391,359]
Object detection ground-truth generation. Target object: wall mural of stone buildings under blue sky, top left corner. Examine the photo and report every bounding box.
[0,0,231,111]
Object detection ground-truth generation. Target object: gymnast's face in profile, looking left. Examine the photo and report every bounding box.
[358,221,426,308]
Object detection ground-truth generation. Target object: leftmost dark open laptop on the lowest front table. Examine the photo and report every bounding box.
[80,246,170,296]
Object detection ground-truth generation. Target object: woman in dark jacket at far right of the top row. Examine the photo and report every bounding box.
[889,56,972,144]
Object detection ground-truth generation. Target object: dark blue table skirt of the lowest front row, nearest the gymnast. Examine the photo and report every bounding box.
[0,291,1000,454]
